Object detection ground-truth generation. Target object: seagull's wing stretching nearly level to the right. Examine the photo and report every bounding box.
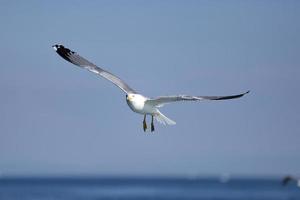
[147,91,250,106]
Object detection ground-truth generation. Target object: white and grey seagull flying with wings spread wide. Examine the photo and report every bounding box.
[52,44,249,132]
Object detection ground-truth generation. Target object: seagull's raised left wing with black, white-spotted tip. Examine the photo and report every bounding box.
[52,44,136,94]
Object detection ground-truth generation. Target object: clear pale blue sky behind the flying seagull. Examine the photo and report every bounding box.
[0,1,300,176]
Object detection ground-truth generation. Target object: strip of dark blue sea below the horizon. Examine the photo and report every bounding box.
[0,178,300,200]
